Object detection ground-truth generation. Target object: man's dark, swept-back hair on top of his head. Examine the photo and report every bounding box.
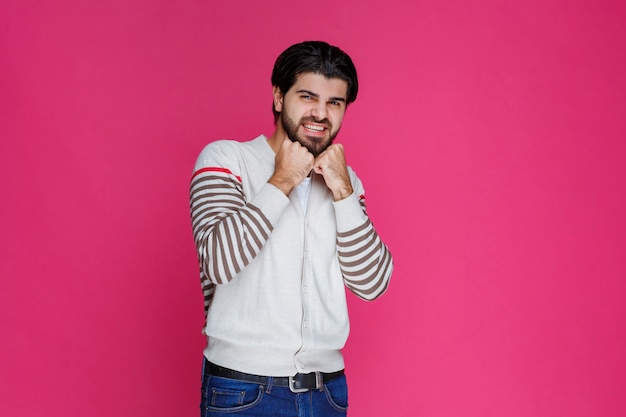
[272,41,359,121]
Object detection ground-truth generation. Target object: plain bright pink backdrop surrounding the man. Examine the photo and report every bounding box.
[0,0,626,417]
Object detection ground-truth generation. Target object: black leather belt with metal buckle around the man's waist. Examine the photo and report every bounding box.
[204,361,343,392]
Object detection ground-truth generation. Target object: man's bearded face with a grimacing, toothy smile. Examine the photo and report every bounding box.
[274,72,348,156]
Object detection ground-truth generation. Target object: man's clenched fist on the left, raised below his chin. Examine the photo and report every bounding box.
[268,137,315,196]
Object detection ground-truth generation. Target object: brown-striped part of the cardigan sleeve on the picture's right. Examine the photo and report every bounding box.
[337,191,393,301]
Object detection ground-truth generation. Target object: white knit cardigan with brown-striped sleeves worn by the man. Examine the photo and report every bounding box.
[190,135,393,376]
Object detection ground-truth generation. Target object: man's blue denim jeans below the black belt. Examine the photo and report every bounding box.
[200,361,348,417]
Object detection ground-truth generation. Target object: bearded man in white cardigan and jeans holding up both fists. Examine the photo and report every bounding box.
[191,41,393,417]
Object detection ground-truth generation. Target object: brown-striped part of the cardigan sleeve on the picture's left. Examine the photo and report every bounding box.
[190,167,272,316]
